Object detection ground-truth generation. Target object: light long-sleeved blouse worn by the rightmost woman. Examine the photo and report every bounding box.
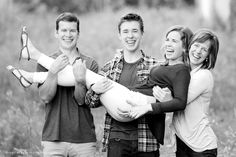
[172,67,217,152]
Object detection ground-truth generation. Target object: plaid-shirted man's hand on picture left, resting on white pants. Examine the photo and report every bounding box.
[92,77,112,94]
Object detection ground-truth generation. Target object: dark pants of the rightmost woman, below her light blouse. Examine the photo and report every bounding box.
[175,136,217,157]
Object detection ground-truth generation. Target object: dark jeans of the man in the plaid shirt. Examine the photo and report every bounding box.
[107,138,160,157]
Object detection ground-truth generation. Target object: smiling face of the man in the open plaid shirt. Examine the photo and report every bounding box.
[119,21,143,53]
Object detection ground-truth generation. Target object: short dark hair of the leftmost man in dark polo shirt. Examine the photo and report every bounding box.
[56,12,80,32]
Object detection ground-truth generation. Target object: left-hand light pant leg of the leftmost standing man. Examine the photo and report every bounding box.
[42,141,68,157]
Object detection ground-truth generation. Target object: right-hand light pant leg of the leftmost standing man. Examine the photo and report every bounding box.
[68,142,96,157]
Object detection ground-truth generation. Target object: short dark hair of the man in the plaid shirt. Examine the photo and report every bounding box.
[118,13,144,34]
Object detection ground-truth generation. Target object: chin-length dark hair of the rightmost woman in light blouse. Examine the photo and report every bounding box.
[189,29,219,69]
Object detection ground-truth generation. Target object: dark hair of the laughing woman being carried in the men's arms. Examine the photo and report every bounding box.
[166,25,193,64]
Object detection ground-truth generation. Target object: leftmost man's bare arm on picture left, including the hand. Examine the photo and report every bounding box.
[39,54,69,103]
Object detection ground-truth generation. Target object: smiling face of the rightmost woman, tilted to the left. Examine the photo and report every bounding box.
[189,40,211,69]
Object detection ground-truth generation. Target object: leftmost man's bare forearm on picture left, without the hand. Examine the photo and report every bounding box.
[39,72,57,103]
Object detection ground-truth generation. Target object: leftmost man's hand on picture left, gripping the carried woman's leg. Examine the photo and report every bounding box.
[49,54,69,74]
